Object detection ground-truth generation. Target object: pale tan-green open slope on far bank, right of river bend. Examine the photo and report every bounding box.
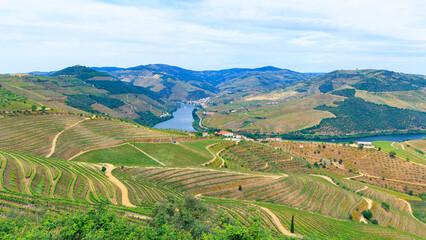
[203,94,344,133]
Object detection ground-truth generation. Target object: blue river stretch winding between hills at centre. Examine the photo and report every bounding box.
[154,103,195,131]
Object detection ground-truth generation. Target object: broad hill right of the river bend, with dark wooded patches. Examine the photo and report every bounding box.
[198,70,426,138]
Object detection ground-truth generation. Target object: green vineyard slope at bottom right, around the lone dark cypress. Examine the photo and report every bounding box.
[205,198,421,239]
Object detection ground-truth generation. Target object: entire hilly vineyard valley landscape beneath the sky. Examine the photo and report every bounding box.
[0,65,426,239]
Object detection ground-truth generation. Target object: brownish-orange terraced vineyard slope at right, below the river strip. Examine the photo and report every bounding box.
[270,141,426,194]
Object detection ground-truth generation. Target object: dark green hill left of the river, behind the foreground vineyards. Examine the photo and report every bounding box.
[0,66,177,126]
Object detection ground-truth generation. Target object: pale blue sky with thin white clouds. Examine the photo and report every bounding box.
[0,0,426,74]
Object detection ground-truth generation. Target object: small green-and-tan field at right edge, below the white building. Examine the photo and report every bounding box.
[373,140,426,164]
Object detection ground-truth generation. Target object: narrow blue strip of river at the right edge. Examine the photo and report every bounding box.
[301,134,426,143]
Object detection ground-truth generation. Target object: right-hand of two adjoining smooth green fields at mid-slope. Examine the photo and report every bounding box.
[136,143,212,166]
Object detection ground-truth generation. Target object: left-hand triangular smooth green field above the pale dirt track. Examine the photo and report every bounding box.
[73,144,160,166]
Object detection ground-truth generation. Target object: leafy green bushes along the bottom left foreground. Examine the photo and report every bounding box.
[0,196,300,239]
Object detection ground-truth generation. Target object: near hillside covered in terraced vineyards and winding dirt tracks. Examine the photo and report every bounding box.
[0,111,425,239]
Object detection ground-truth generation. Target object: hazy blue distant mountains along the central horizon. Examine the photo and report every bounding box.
[93,64,317,100]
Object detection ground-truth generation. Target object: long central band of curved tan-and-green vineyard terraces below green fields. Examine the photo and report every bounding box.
[117,168,364,219]
